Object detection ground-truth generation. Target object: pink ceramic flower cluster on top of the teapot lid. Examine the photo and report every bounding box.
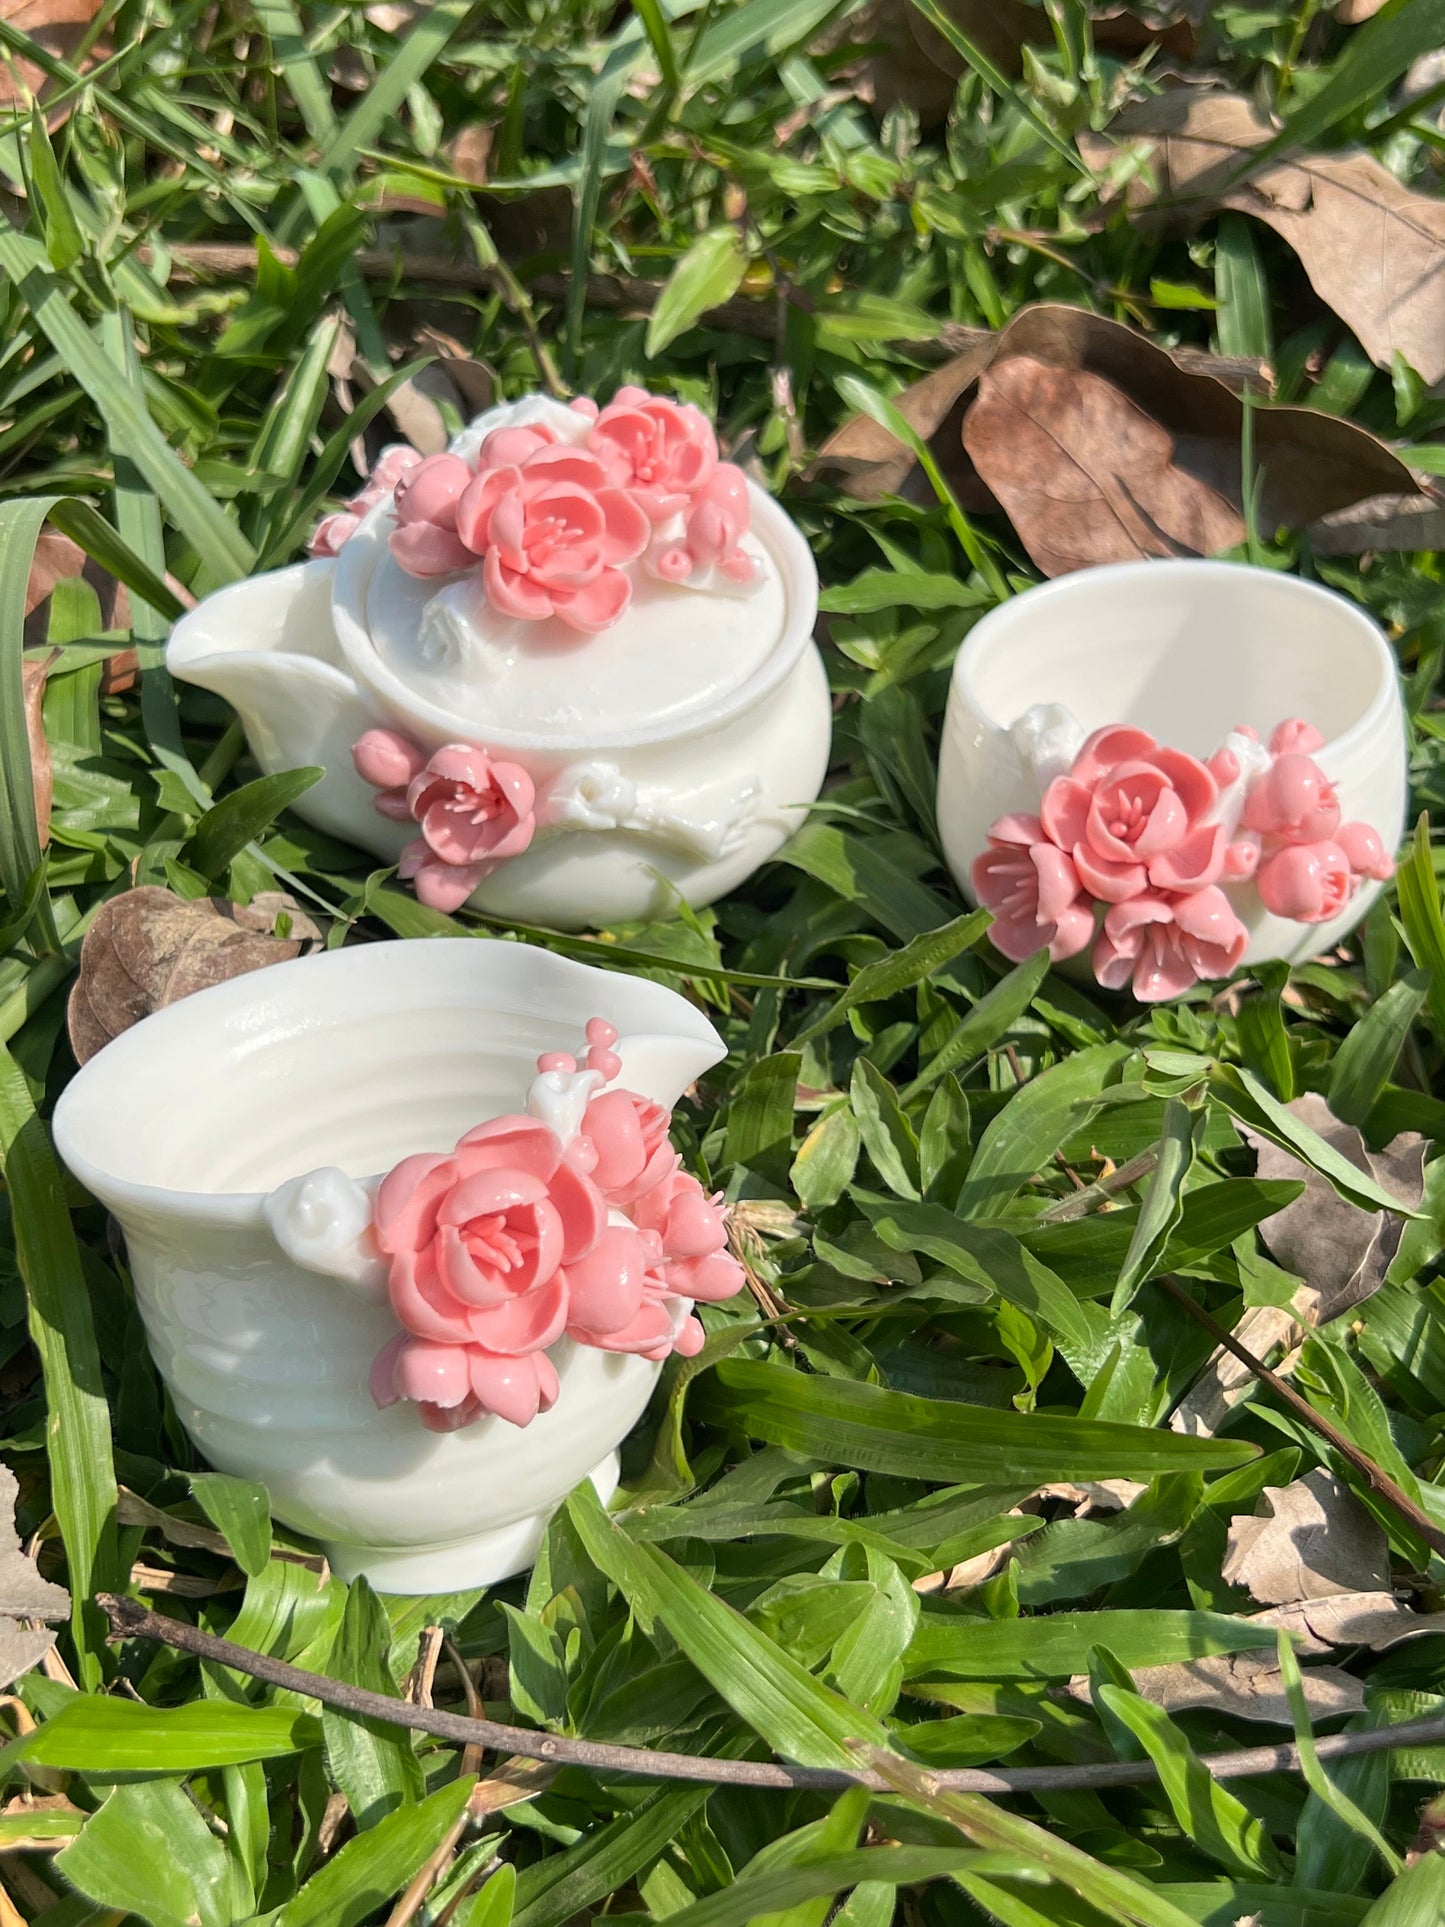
[391,387,753,634]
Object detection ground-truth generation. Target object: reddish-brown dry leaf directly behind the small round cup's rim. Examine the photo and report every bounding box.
[963,355,1245,576]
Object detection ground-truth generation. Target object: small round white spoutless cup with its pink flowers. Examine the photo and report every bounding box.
[938,561,1406,1002]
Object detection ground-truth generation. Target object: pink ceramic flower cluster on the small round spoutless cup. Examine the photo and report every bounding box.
[971,721,1395,1004]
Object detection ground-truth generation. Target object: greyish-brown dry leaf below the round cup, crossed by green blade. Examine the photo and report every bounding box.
[1245,1091,1428,1326]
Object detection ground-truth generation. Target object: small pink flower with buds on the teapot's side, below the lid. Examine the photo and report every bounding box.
[351,728,538,911]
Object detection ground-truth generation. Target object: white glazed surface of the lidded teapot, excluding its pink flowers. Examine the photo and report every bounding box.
[166,399,832,929]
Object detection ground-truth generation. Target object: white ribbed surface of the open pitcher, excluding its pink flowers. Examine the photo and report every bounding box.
[54,938,724,1592]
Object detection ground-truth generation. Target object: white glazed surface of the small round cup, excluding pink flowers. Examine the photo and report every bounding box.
[938,561,1406,967]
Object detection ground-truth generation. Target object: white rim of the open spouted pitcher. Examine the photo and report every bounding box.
[50,937,726,1229]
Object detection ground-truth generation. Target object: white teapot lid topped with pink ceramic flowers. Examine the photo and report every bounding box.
[335,389,793,742]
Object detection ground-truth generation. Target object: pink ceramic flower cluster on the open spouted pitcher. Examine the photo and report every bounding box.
[372,1017,744,1432]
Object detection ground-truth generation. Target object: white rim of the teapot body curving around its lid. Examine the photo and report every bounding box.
[331,478,819,757]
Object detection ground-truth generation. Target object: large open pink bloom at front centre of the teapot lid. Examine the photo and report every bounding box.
[457,445,649,634]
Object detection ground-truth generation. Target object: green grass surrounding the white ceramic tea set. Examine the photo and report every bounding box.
[0,0,1445,1927]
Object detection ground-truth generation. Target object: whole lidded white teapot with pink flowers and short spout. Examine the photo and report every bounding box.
[168,387,832,929]
